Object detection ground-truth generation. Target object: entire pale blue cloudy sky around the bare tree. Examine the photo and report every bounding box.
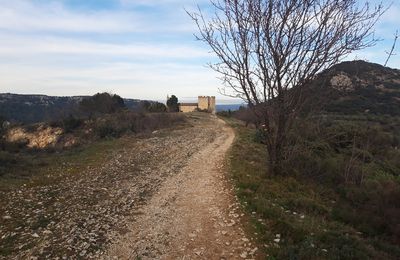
[0,0,400,103]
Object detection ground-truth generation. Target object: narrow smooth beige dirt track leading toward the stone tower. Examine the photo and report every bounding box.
[106,119,257,259]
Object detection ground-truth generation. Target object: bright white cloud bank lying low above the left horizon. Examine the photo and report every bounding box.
[0,63,218,99]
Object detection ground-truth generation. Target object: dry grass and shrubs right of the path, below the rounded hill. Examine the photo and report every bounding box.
[223,115,400,259]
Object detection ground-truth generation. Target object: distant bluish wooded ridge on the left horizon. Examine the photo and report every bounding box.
[0,93,140,123]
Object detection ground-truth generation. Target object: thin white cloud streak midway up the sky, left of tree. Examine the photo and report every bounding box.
[0,35,210,59]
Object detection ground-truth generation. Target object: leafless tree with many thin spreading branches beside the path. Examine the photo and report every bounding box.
[189,0,384,174]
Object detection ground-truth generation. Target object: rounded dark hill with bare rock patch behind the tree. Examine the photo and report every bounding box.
[311,61,400,116]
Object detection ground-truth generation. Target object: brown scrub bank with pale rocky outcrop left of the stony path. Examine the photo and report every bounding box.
[0,111,185,183]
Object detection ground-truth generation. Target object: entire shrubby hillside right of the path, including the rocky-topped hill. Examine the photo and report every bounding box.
[225,61,400,259]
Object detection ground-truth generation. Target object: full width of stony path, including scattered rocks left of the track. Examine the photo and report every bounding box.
[0,114,257,259]
